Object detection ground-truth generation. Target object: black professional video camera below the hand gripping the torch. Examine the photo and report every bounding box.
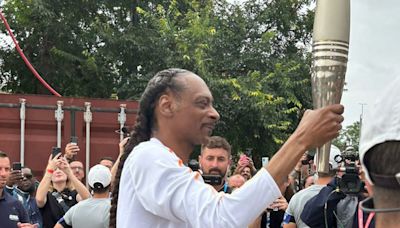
[335,147,364,195]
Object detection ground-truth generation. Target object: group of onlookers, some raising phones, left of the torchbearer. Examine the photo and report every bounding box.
[0,138,128,228]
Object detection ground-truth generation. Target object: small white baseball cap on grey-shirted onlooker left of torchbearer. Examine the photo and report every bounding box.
[88,165,111,189]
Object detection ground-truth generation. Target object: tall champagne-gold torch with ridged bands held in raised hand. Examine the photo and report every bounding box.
[311,0,350,173]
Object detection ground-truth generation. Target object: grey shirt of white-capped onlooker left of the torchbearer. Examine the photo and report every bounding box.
[63,198,111,228]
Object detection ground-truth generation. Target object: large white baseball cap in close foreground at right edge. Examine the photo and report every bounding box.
[359,77,400,184]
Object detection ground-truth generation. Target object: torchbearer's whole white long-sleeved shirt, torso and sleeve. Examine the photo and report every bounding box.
[117,138,281,228]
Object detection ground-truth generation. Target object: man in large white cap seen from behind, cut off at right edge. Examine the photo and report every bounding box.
[359,78,400,228]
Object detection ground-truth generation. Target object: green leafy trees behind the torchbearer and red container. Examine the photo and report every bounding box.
[0,0,313,164]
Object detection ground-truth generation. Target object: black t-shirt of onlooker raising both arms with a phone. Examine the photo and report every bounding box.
[40,188,78,228]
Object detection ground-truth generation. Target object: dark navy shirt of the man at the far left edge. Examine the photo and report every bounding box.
[0,189,29,228]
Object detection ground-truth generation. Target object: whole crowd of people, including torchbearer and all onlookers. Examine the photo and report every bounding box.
[0,69,400,228]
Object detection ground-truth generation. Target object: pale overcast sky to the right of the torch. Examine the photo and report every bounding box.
[341,0,400,126]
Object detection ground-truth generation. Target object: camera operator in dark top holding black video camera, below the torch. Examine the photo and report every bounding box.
[301,148,374,228]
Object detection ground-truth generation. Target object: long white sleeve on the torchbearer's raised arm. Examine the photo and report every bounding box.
[129,144,281,227]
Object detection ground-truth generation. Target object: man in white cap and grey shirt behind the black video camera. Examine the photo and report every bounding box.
[283,145,341,228]
